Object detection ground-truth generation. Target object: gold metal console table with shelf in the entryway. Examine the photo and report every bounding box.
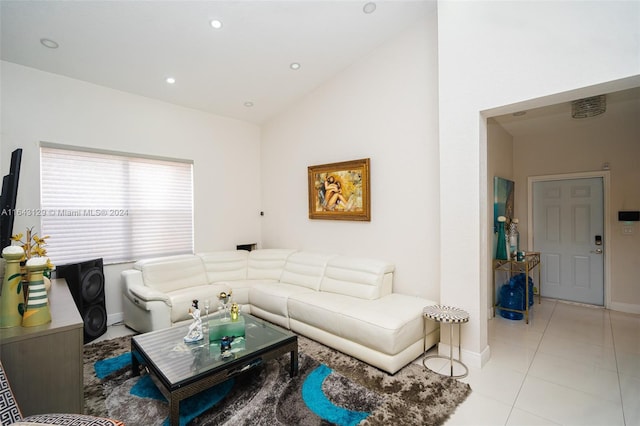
[493,252,541,324]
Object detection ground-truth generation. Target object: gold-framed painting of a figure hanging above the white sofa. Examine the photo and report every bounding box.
[308,158,371,221]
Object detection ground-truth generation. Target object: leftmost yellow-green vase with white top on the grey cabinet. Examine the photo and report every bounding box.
[0,246,24,328]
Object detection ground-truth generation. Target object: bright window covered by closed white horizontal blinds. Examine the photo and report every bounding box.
[40,144,193,265]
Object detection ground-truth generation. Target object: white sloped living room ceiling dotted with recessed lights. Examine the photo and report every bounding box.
[0,0,436,123]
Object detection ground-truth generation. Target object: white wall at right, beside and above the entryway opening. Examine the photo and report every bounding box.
[438,1,640,365]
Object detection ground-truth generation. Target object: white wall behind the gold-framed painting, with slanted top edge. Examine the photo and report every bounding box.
[262,16,439,301]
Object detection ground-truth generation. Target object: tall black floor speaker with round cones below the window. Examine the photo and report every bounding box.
[56,259,107,343]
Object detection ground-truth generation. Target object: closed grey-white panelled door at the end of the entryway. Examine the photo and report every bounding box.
[533,177,605,306]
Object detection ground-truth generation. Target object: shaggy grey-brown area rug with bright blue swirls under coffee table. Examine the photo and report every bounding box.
[84,337,471,426]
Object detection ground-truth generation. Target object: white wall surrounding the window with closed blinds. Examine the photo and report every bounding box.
[0,62,260,320]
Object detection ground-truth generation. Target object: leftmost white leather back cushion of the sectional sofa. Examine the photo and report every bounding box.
[135,255,208,293]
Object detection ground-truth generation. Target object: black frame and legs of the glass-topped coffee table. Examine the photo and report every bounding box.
[131,314,298,426]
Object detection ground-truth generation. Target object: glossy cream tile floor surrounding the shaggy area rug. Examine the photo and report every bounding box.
[96,299,640,426]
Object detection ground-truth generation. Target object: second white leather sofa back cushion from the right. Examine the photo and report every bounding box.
[280,251,336,290]
